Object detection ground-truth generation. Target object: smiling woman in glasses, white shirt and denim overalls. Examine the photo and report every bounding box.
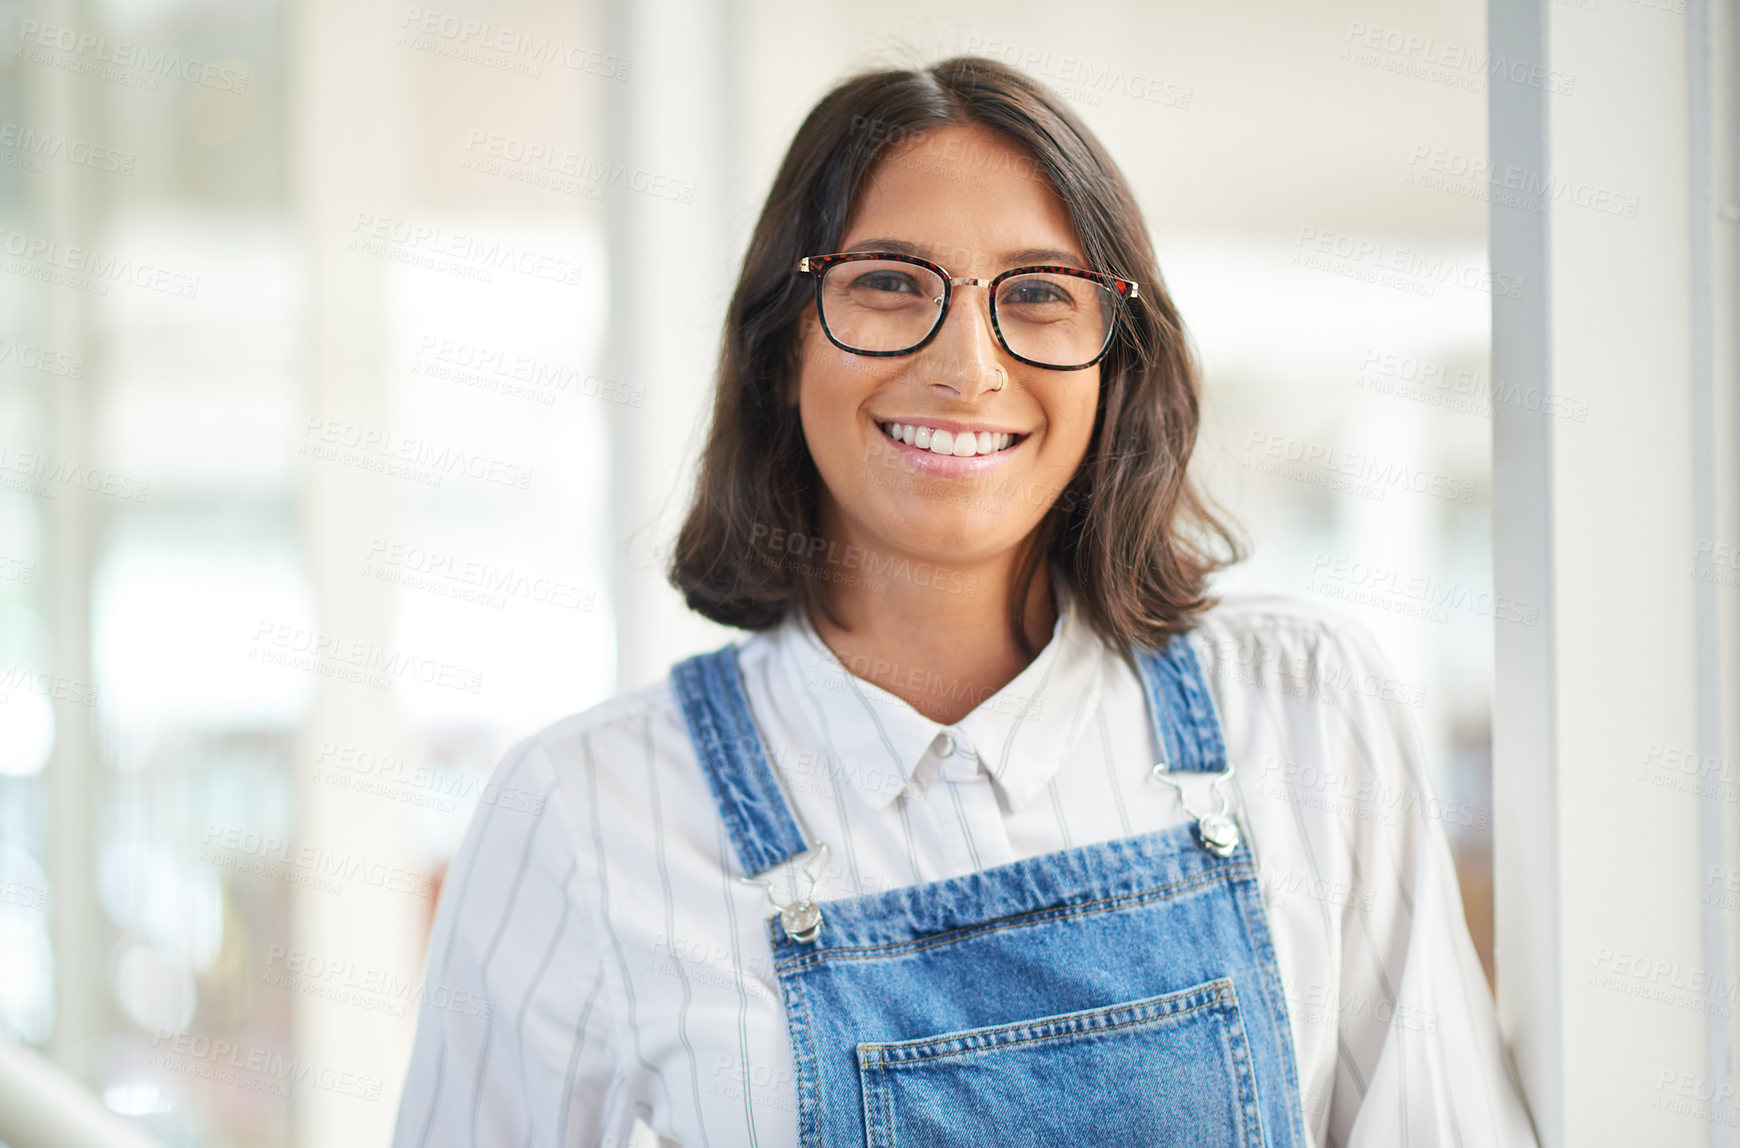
[395,57,1533,1148]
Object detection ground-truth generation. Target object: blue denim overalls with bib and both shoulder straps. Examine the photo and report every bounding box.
[672,635,1307,1148]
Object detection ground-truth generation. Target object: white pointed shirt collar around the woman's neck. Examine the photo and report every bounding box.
[774,583,1105,811]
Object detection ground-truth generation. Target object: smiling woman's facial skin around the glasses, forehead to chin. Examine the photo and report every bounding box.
[797,125,1100,567]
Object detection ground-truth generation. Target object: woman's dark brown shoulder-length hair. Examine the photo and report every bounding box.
[670,56,1244,656]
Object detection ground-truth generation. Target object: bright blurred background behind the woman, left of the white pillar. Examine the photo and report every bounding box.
[0,0,1496,1148]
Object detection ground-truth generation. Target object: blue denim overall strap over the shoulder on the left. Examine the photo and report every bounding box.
[670,645,806,877]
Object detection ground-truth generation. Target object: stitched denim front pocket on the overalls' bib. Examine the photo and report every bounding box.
[858,978,1263,1148]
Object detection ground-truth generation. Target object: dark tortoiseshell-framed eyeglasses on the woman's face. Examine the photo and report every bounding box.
[797,250,1140,370]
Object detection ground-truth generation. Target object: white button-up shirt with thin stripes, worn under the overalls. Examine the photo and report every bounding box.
[393,593,1536,1148]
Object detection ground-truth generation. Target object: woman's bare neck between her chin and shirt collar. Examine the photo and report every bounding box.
[811,514,1056,725]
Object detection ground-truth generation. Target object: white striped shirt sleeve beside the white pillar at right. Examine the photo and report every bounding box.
[1322,621,1536,1148]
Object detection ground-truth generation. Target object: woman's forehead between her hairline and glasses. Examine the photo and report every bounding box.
[840,123,1082,275]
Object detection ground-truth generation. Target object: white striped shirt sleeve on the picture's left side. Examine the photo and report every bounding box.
[393,739,614,1148]
